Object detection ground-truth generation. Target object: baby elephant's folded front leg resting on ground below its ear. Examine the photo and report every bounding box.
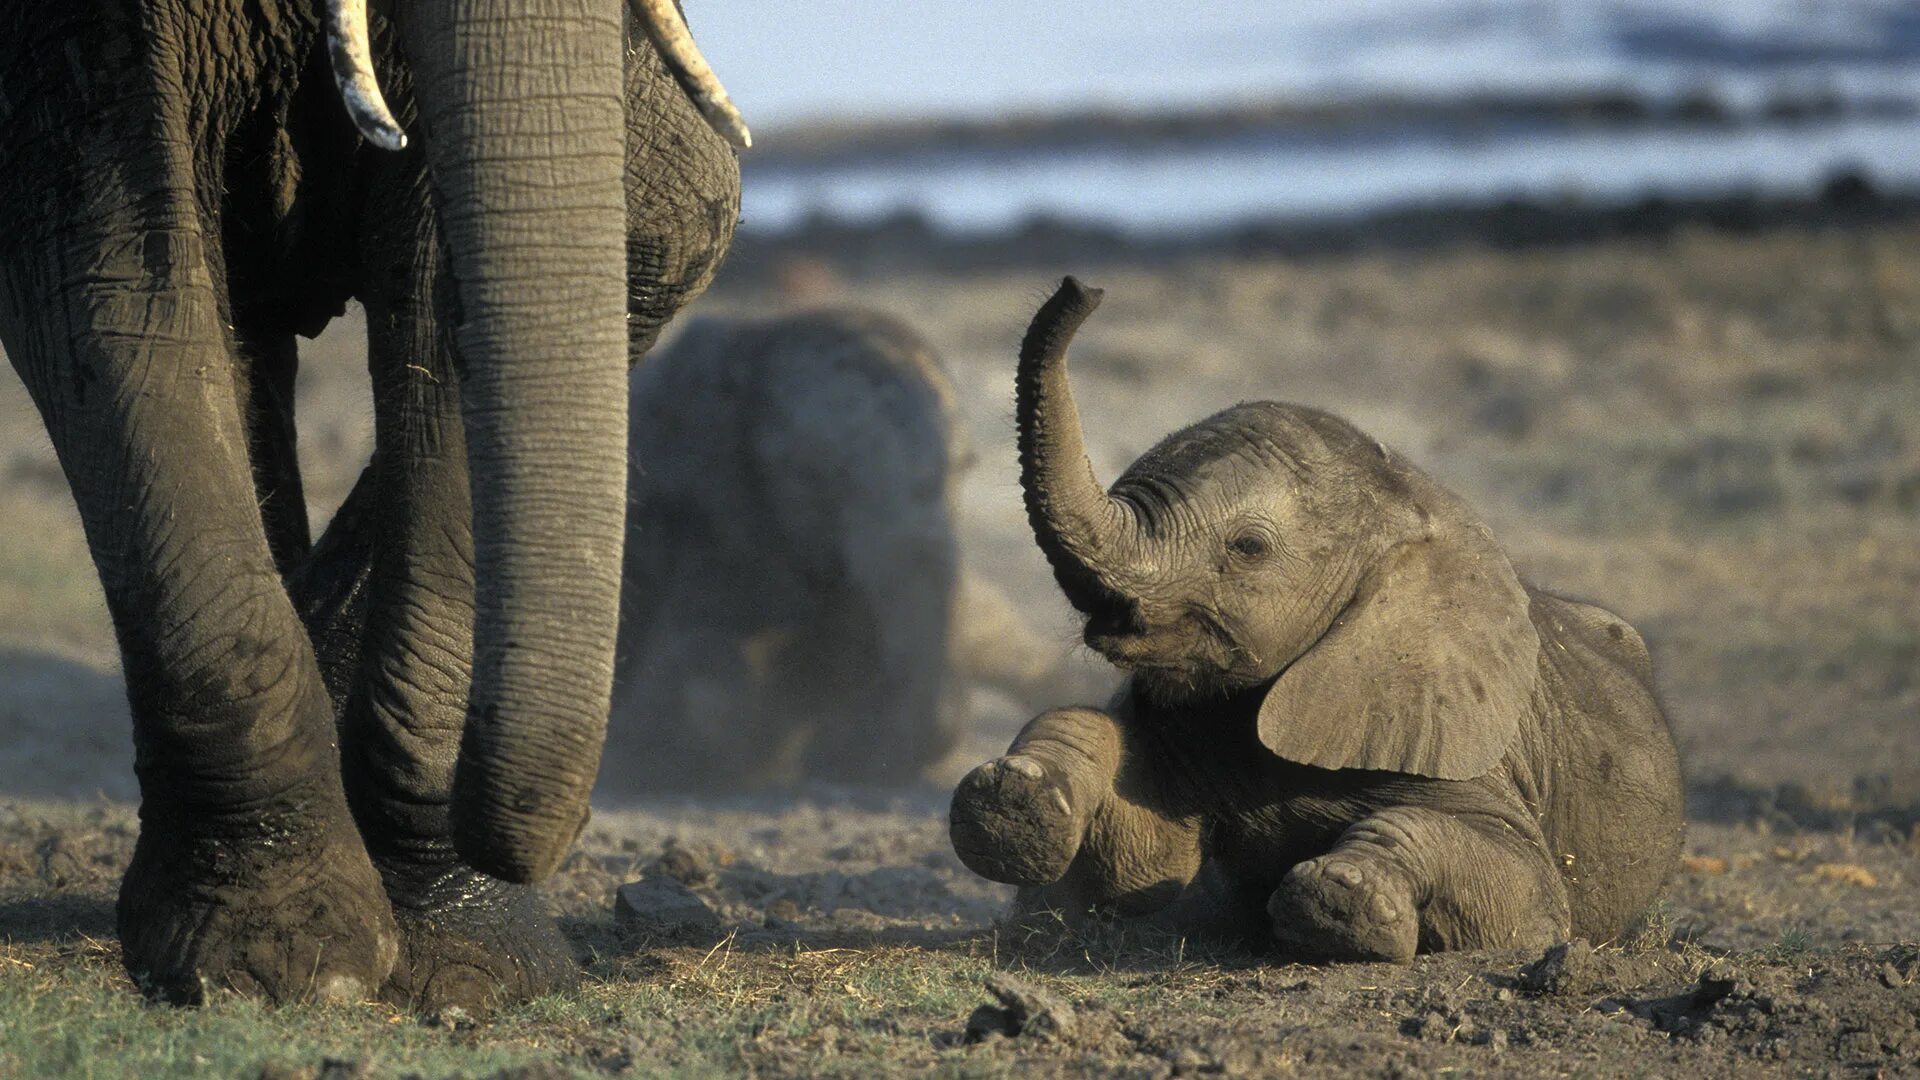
[1267,807,1567,963]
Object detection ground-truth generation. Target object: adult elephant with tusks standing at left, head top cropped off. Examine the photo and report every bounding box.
[0,0,745,1007]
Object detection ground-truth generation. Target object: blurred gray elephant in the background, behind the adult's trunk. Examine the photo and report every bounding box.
[601,311,966,796]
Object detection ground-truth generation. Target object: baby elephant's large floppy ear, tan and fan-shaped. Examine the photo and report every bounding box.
[1260,528,1540,780]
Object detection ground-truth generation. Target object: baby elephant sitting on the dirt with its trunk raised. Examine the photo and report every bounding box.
[950,279,1684,961]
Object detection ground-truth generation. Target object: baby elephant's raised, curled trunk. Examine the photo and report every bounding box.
[1014,277,1140,609]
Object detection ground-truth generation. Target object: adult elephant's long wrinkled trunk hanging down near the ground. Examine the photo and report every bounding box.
[399,0,628,882]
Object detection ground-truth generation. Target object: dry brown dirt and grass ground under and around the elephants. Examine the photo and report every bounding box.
[0,214,1920,1076]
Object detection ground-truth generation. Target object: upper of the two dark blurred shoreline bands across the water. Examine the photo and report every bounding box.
[741,88,1920,175]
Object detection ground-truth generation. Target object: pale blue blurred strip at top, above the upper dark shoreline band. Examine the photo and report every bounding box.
[689,0,1920,127]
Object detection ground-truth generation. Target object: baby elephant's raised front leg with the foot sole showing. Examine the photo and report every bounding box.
[948,707,1200,915]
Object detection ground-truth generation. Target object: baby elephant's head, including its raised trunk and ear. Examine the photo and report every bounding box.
[1018,277,1538,772]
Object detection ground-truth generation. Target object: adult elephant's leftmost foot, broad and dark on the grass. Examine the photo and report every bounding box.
[117,807,399,1005]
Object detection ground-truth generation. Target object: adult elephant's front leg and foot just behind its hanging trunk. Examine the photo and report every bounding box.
[341,158,578,1011]
